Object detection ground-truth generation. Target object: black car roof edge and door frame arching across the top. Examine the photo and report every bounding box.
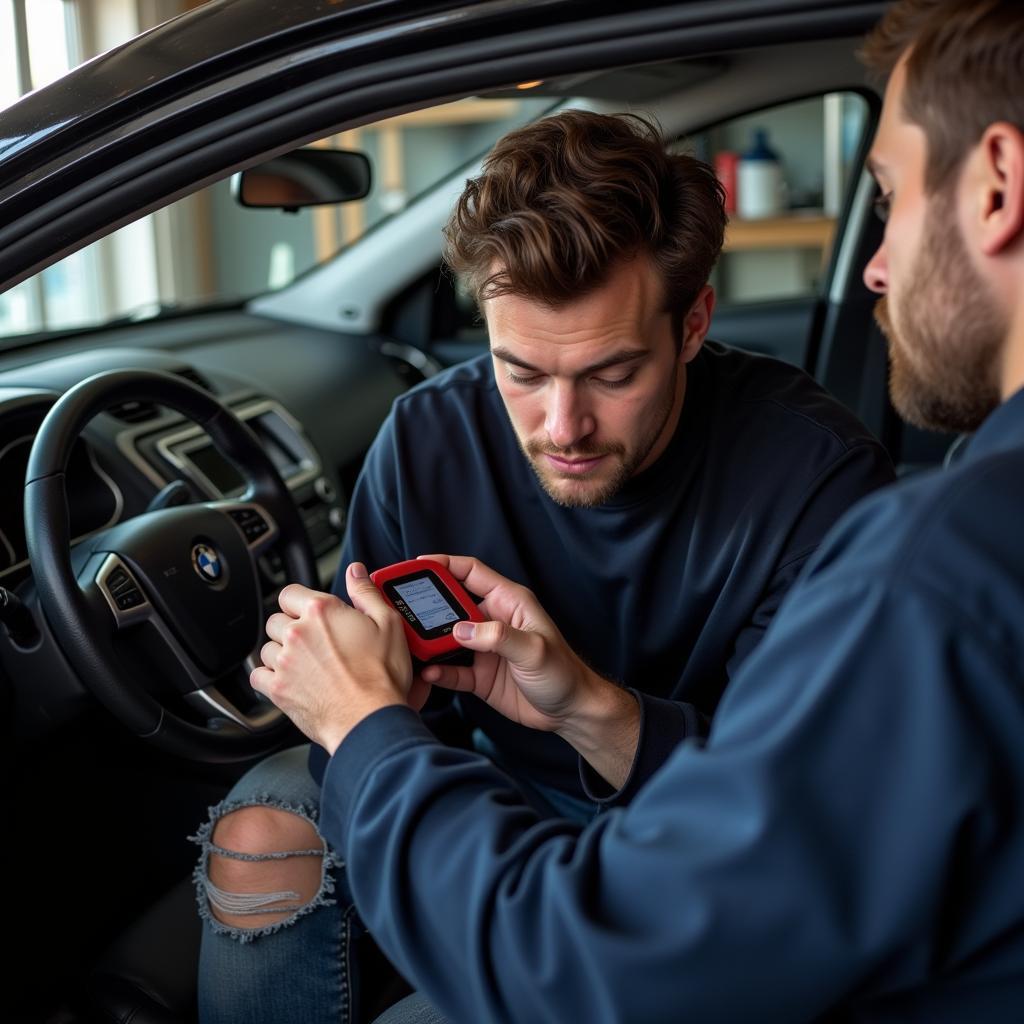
[0,0,885,289]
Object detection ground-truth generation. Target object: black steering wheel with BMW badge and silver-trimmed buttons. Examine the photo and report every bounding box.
[25,370,319,762]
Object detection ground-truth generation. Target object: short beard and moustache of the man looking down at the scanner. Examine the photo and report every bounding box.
[517,364,679,509]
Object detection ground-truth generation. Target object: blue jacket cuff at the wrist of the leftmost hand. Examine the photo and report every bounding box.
[321,705,437,850]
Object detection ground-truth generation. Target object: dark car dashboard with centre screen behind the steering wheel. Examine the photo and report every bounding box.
[0,312,413,738]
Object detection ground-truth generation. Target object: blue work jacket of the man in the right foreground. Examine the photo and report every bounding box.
[323,392,1024,1024]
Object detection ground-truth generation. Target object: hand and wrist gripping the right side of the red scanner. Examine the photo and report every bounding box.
[422,555,640,788]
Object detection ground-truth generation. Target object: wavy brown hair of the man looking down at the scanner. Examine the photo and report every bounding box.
[444,111,726,322]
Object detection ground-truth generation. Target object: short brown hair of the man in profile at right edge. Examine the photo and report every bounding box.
[860,0,1024,193]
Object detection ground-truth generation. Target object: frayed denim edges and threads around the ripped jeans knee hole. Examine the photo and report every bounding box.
[187,796,342,943]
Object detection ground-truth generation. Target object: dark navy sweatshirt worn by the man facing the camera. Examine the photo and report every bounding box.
[310,342,893,801]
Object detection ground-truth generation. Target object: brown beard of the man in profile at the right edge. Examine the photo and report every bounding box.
[874,198,1009,432]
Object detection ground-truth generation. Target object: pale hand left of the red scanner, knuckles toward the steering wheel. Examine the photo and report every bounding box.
[250,562,415,755]
